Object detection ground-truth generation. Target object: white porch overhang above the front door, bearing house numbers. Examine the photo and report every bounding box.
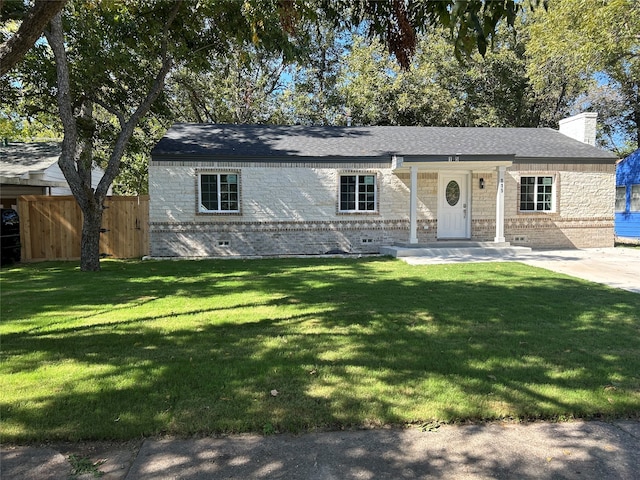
[391,154,515,173]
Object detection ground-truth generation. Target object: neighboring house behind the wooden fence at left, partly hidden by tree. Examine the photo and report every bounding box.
[0,142,108,209]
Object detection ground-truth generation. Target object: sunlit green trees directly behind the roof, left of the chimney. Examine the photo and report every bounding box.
[340,24,541,127]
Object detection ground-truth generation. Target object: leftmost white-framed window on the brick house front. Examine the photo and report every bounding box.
[198,173,240,213]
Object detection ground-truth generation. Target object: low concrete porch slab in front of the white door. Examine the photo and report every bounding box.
[380,241,531,258]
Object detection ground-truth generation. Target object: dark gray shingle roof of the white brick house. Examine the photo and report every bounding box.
[152,123,616,162]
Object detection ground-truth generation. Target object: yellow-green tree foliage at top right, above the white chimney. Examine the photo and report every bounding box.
[527,0,640,152]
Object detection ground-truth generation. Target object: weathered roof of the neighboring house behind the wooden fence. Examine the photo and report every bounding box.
[0,143,67,187]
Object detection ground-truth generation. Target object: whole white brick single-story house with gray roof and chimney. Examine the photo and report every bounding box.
[149,113,616,257]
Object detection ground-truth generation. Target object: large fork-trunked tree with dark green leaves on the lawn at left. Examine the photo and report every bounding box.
[40,0,310,270]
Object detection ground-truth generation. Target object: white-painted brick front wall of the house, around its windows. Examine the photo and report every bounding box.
[149,162,615,257]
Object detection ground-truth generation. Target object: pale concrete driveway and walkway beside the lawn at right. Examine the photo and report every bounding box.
[402,247,640,293]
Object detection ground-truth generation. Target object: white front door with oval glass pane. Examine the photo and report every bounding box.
[438,173,470,238]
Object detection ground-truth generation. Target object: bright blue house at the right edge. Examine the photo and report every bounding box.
[615,149,640,243]
